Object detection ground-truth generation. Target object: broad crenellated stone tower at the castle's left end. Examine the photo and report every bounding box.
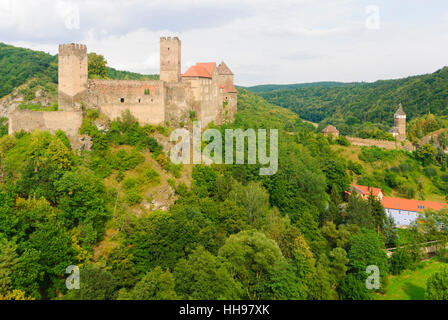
[58,43,88,111]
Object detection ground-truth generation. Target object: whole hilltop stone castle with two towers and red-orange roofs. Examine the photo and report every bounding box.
[9,37,237,139]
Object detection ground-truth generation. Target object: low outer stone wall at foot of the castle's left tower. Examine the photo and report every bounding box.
[8,110,82,141]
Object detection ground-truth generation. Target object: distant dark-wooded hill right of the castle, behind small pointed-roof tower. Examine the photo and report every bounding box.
[247,67,448,126]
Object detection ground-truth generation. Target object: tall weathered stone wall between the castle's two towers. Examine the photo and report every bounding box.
[86,80,166,124]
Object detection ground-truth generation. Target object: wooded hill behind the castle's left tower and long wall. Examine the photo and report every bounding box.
[0,43,159,98]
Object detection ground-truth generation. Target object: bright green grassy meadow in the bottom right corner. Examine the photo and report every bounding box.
[375,259,447,300]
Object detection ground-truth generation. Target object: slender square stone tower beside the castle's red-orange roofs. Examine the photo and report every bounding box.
[160,37,182,82]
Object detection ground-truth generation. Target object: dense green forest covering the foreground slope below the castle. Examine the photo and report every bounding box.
[0,89,448,300]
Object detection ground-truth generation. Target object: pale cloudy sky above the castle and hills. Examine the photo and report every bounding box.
[0,0,448,86]
